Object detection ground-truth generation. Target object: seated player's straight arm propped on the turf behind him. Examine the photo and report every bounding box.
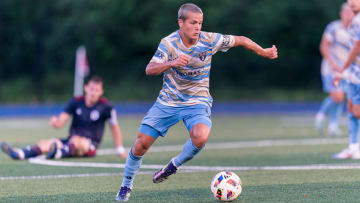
[109,109,127,158]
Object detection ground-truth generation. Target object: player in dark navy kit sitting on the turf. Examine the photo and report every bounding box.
[1,76,126,160]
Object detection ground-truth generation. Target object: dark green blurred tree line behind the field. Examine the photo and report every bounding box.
[0,0,343,102]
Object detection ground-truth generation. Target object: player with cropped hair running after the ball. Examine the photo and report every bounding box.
[115,3,277,201]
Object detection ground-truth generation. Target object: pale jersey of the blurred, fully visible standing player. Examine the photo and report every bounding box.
[321,20,350,76]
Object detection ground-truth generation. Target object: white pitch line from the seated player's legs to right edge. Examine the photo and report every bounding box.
[29,158,360,172]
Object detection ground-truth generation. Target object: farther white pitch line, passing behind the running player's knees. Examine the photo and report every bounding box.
[96,138,348,156]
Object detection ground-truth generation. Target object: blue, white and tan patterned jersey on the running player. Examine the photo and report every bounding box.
[150,31,235,107]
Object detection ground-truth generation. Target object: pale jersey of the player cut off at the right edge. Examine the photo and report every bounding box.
[349,13,360,84]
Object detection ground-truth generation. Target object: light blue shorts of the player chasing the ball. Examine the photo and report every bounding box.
[139,102,212,138]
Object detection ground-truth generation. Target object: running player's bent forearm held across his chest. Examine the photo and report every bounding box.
[145,55,190,75]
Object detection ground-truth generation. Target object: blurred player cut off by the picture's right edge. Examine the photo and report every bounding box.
[333,0,360,159]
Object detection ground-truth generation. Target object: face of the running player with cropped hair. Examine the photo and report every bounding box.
[179,12,203,40]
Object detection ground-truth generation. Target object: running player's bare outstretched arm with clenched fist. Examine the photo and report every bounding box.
[233,36,278,59]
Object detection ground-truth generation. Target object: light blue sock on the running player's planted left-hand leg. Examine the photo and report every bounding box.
[121,149,143,188]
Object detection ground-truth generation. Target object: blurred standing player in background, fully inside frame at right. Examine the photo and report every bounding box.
[315,3,354,136]
